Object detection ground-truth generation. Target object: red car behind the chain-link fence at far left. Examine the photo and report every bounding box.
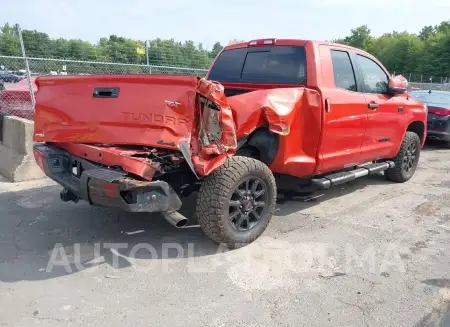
[0,77,37,120]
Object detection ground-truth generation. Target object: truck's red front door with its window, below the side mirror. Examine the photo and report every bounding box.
[355,53,408,161]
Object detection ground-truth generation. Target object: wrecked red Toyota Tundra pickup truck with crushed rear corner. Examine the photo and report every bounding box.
[34,39,427,248]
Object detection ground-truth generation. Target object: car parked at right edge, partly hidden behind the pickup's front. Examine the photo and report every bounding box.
[409,90,450,146]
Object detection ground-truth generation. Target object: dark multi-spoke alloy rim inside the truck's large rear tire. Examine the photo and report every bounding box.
[228,177,268,232]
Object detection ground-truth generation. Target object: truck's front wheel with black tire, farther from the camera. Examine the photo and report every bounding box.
[386,132,420,183]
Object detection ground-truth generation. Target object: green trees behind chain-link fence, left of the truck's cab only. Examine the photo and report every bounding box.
[0,23,223,73]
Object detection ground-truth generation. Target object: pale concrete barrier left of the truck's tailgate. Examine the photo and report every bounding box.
[0,116,45,182]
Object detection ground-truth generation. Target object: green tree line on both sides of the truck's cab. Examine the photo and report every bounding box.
[0,20,450,77]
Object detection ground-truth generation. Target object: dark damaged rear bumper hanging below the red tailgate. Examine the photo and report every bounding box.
[34,144,181,212]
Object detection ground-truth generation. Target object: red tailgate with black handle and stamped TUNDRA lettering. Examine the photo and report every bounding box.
[34,75,198,148]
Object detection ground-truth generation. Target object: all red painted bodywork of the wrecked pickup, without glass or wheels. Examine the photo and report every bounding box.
[35,40,426,179]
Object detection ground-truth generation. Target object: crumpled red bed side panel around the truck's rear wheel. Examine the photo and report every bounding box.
[192,79,322,176]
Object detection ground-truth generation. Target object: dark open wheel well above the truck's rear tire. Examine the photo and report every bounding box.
[236,127,279,166]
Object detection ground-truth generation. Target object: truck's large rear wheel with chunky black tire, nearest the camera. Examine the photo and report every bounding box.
[197,156,277,248]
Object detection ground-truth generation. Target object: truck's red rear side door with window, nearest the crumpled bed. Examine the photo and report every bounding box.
[319,45,367,173]
